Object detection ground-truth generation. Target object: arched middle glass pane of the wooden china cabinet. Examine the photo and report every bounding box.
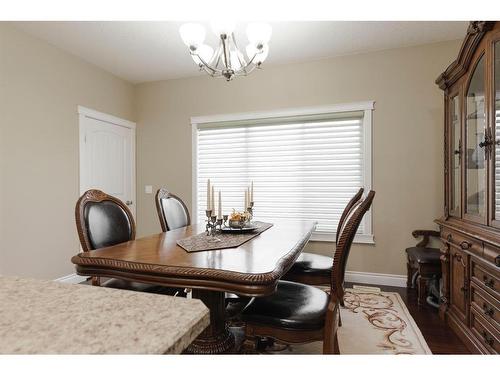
[463,55,487,222]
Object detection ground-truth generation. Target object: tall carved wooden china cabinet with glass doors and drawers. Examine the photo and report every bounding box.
[436,21,500,354]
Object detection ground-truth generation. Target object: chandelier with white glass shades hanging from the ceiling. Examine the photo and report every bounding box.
[179,22,272,81]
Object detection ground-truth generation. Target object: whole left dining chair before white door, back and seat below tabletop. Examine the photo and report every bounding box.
[75,189,180,294]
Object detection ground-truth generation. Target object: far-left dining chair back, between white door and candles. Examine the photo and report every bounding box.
[155,188,191,232]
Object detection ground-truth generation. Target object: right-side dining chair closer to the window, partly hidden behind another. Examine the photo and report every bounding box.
[283,188,364,285]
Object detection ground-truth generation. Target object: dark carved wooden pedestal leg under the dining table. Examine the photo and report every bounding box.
[186,289,235,354]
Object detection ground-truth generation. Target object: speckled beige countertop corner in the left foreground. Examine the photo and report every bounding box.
[0,276,210,354]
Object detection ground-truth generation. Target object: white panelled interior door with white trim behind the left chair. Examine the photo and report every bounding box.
[79,107,136,217]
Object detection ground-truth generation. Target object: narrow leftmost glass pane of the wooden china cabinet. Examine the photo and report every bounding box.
[449,95,462,217]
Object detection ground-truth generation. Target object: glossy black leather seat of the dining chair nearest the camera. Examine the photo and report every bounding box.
[241,281,329,330]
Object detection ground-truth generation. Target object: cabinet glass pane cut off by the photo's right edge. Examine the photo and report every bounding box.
[493,41,500,220]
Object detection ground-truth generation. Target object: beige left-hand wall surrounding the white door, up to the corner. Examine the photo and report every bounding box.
[0,23,134,278]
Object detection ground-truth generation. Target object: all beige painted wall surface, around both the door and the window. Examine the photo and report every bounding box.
[0,23,460,278]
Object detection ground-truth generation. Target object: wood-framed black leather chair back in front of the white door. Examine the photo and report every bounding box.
[75,190,135,251]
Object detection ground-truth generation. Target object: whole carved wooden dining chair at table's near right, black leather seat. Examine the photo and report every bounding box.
[241,191,375,354]
